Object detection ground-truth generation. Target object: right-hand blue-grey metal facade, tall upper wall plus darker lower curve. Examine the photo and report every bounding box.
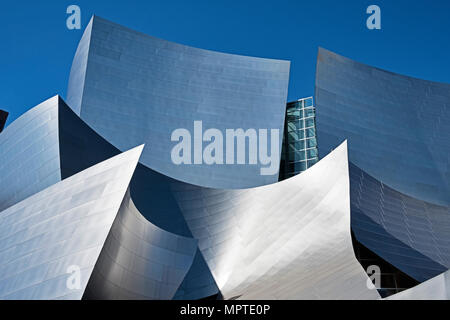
[316,49,450,281]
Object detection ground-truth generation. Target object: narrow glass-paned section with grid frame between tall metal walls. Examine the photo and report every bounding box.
[279,97,319,181]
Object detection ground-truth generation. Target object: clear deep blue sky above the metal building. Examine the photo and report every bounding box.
[0,0,450,123]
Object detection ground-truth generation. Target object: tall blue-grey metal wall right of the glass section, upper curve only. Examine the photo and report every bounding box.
[316,48,450,206]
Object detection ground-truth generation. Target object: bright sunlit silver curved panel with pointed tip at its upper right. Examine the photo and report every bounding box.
[174,144,379,299]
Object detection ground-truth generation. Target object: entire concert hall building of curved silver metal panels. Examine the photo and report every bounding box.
[0,16,450,300]
